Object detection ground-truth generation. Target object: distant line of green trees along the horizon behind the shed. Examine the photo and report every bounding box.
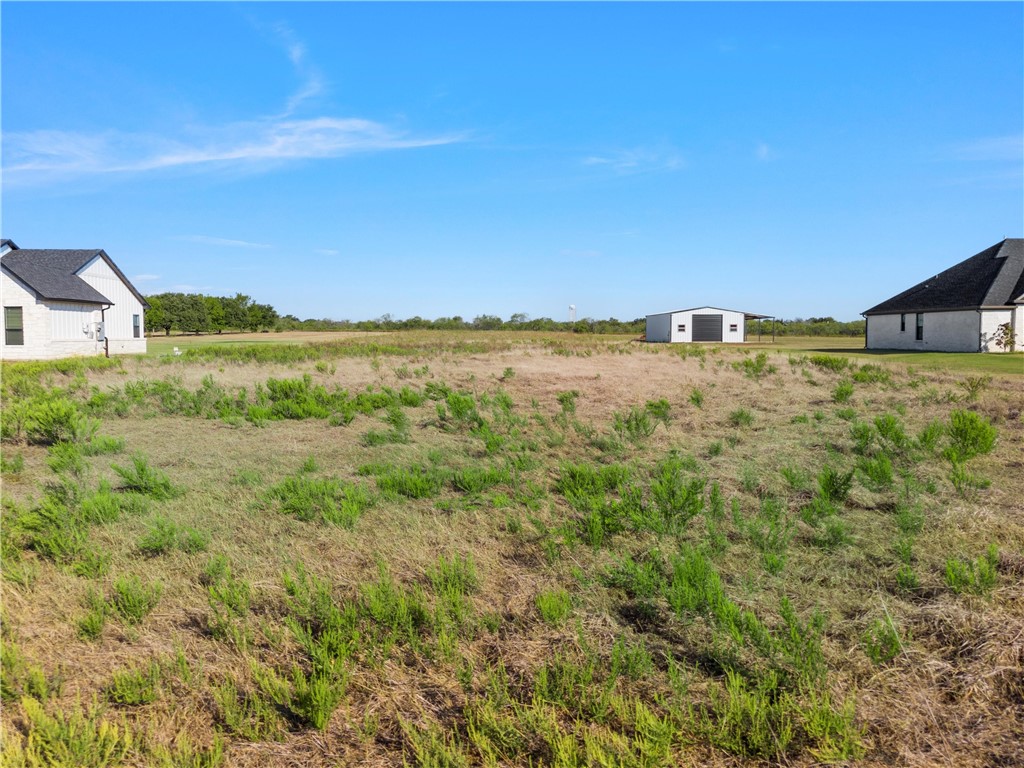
[145,293,864,337]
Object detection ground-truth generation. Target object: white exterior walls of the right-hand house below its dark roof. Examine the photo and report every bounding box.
[866,307,1024,352]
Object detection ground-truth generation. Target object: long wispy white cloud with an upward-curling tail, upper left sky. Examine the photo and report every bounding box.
[3,25,466,183]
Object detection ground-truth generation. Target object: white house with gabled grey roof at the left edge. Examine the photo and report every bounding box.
[0,240,147,360]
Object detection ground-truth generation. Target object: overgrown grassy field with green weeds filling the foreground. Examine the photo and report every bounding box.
[0,332,1024,768]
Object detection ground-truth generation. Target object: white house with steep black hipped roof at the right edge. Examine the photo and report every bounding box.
[862,238,1024,352]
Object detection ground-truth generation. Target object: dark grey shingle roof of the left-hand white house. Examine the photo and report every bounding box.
[0,246,148,306]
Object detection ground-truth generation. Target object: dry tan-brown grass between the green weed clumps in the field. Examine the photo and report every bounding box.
[2,341,1024,768]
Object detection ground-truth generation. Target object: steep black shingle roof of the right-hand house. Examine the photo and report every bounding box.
[862,238,1024,314]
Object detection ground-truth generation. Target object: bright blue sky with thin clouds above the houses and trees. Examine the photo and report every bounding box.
[0,2,1024,319]
